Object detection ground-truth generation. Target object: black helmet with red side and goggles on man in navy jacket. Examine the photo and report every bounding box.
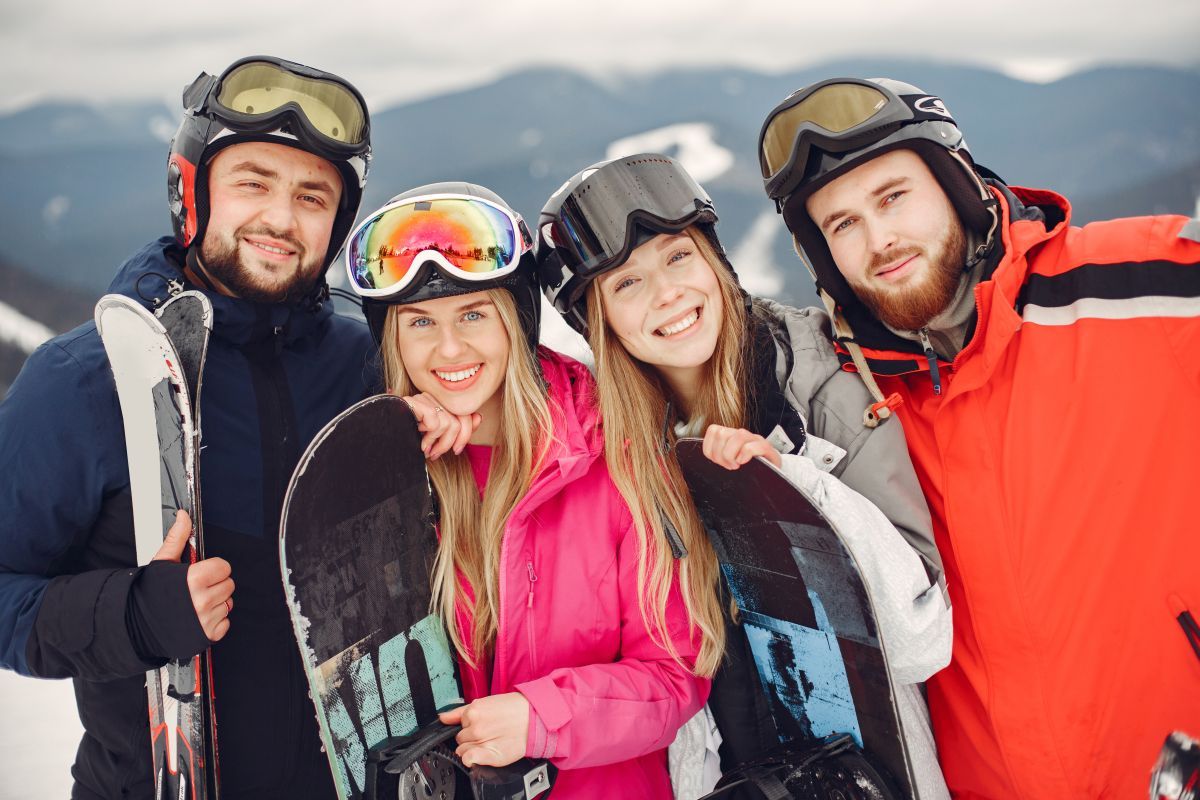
[167,55,371,272]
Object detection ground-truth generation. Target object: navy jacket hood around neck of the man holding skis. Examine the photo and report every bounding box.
[108,236,334,347]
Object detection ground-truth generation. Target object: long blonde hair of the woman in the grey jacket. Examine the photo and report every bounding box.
[587,228,749,676]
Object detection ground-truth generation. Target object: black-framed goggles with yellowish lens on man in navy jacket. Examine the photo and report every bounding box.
[184,55,370,160]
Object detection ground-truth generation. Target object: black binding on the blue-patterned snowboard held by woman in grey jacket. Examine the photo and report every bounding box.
[700,733,902,800]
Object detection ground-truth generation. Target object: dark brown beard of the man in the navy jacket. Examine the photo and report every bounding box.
[200,228,322,305]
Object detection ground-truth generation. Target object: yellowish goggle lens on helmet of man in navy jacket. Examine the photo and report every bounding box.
[216,61,366,145]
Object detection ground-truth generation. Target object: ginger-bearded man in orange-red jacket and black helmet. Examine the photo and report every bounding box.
[758,78,1200,799]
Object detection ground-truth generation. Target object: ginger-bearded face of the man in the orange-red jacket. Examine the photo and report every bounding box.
[805,150,966,330]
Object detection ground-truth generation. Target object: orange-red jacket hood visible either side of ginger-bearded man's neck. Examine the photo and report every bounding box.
[836,180,1070,375]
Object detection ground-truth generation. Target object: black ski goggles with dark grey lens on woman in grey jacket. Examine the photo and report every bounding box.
[541,154,716,277]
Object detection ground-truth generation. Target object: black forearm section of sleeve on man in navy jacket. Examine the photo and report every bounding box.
[26,569,163,680]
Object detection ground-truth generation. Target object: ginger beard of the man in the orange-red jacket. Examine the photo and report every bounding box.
[852,221,967,331]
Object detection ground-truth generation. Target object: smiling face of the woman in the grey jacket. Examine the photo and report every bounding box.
[599,233,722,390]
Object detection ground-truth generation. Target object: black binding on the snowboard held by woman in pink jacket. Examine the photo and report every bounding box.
[364,721,558,800]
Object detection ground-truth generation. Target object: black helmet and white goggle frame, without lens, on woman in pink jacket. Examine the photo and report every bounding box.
[344,181,541,354]
